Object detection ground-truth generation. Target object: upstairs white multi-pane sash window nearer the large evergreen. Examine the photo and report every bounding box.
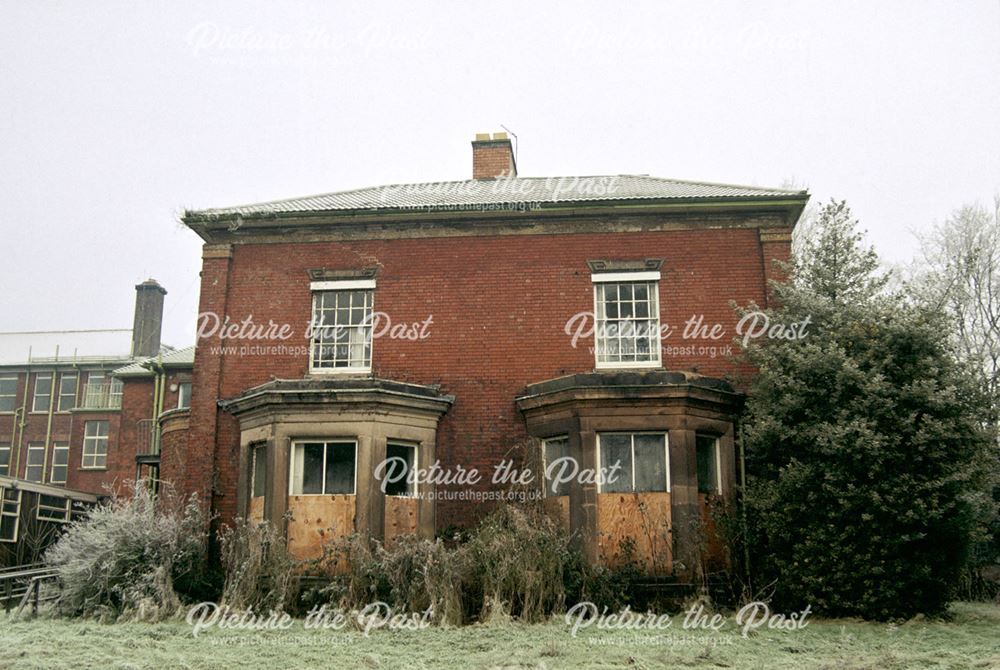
[591,271,660,368]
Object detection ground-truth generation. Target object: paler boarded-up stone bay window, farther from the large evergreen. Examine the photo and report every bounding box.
[221,376,454,560]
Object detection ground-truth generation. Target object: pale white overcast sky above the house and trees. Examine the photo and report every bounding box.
[0,0,1000,346]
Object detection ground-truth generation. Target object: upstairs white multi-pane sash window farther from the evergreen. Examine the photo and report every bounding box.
[309,279,375,373]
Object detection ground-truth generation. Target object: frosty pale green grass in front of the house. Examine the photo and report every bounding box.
[0,603,1000,670]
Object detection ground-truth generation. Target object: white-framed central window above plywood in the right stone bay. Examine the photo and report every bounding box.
[597,433,670,493]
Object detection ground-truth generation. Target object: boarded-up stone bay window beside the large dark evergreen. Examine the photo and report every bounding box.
[516,370,742,577]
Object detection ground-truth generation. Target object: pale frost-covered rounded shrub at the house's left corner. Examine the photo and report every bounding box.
[45,487,206,620]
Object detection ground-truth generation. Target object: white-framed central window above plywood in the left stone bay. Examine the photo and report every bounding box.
[289,440,358,495]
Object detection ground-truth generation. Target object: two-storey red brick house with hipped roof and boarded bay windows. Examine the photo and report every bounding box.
[178,133,808,573]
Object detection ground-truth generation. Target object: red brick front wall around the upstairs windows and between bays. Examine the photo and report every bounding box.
[185,228,781,527]
